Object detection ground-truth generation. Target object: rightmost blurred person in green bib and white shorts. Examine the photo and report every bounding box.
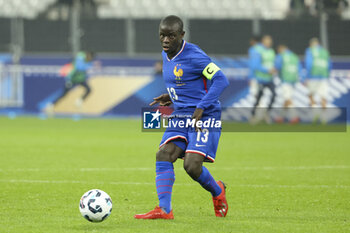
[305,38,332,109]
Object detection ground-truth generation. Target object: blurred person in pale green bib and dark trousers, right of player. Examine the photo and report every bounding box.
[251,35,276,123]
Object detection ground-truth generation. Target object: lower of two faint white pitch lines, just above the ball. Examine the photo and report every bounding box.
[0,179,350,189]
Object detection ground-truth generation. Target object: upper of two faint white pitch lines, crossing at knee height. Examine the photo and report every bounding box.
[0,165,350,172]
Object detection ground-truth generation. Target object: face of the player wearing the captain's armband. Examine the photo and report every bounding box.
[159,24,185,55]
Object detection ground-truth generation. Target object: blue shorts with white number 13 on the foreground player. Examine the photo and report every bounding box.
[159,114,221,162]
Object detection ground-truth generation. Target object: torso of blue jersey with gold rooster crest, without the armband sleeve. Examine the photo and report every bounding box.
[162,41,220,113]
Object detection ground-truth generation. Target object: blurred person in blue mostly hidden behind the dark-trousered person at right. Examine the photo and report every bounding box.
[248,35,262,97]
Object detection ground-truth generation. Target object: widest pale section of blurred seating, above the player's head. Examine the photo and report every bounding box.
[96,0,289,19]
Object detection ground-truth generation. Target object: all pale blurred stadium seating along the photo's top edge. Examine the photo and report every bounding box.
[0,0,350,19]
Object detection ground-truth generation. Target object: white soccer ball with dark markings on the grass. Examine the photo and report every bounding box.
[79,189,112,222]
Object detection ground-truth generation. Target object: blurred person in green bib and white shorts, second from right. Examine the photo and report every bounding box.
[275,44,303,123]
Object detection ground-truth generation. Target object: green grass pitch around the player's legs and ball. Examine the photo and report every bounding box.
[0,117,350,233]
